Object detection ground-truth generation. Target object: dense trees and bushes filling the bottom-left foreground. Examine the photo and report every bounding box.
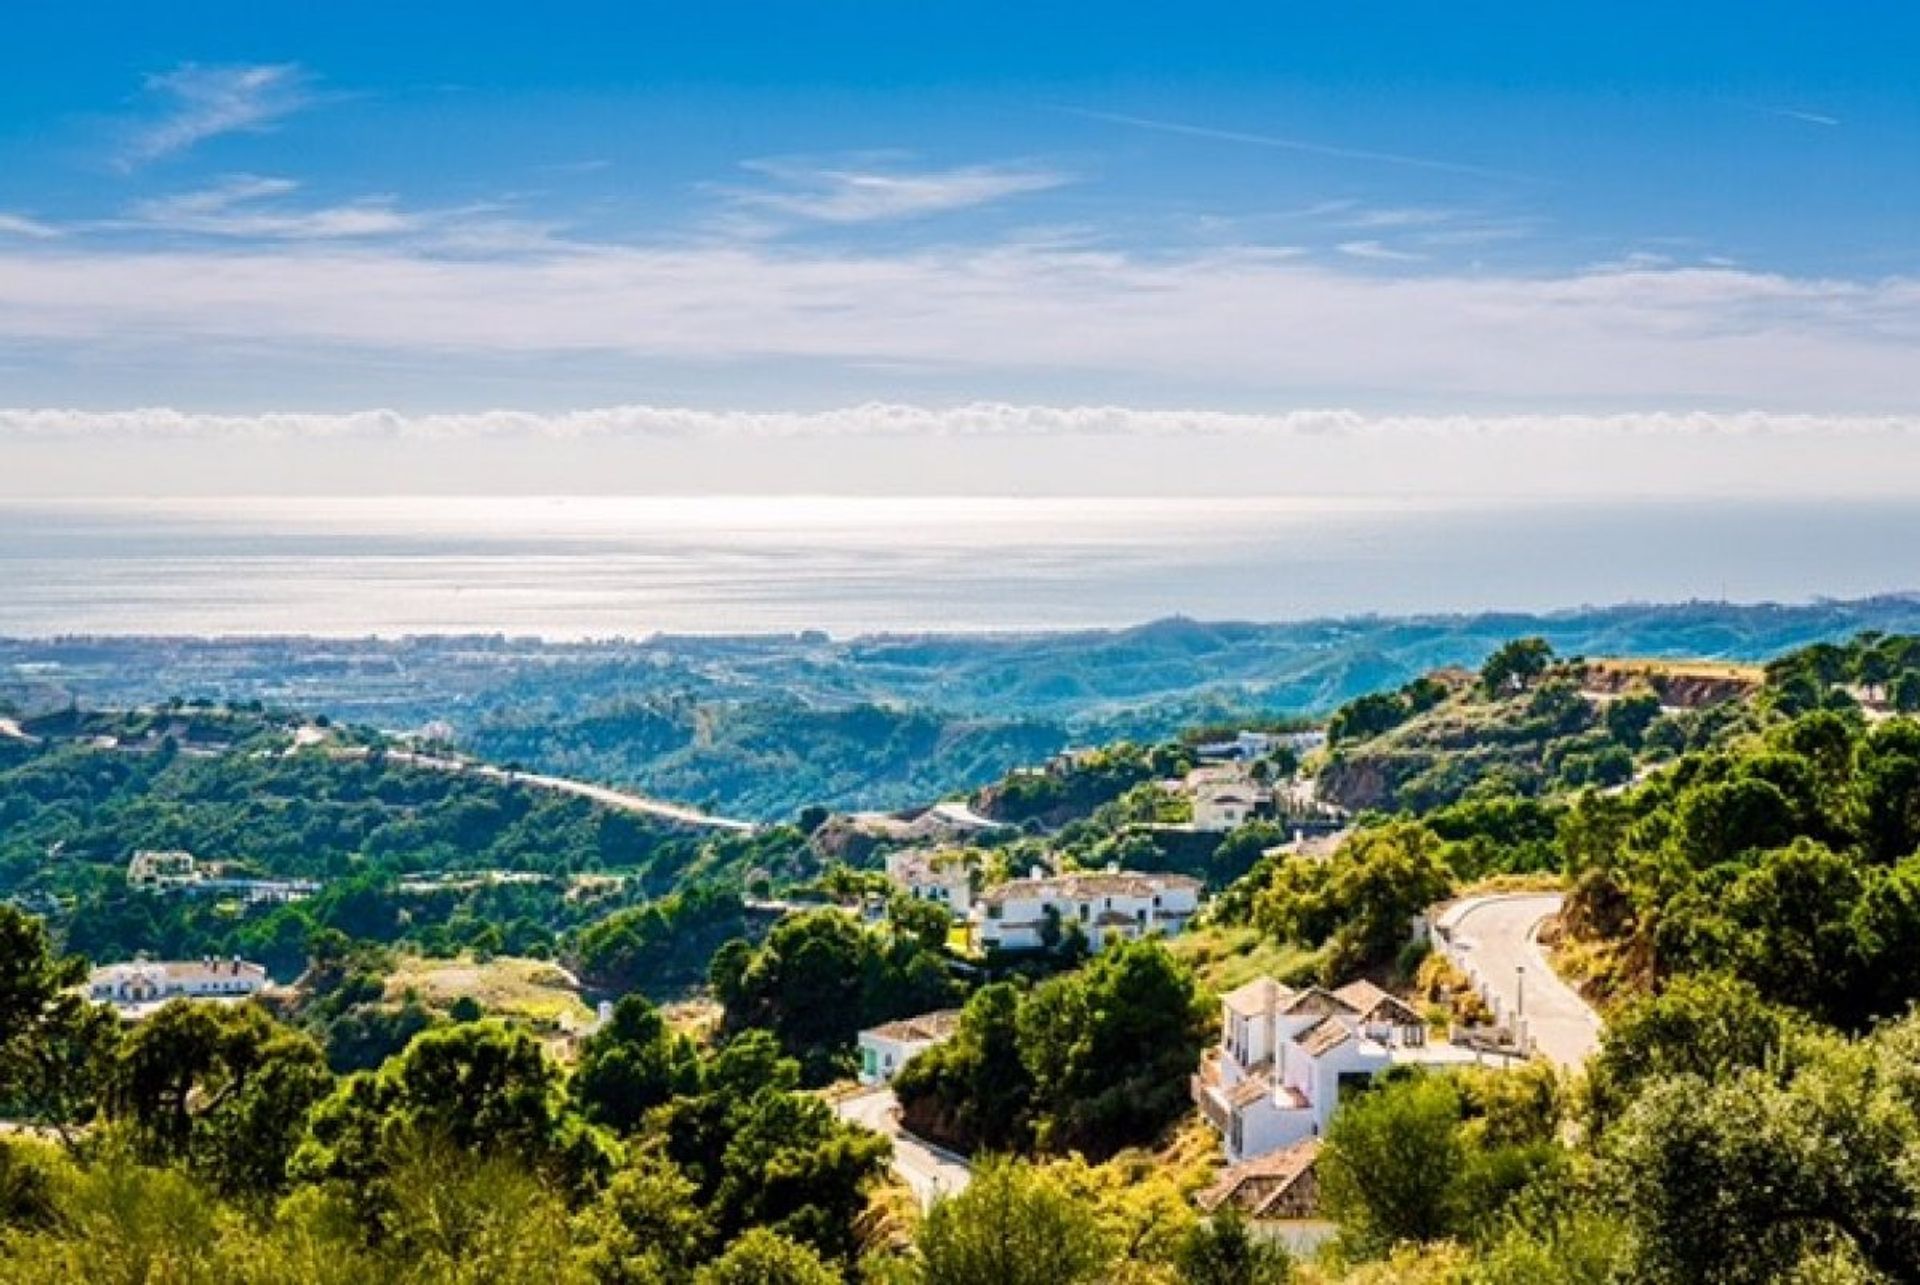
[0,907,906,1285]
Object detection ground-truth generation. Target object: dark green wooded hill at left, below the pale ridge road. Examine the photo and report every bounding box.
[0,709,814,982]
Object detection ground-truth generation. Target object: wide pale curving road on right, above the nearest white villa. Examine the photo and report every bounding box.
[1440,893,1601,1066]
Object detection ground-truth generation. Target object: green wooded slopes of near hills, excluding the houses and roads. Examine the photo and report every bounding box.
[11,634,1920,1285]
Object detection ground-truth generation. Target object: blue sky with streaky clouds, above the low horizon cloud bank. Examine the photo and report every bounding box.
[0,2,1920,486]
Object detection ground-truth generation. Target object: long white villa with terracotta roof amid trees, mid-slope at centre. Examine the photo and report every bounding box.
[970,870,1200,951]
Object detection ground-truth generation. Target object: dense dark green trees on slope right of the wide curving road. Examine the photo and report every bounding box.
[1563,711,1920,1030]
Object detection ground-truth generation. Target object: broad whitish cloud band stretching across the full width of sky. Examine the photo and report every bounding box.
[0,236,1920,411]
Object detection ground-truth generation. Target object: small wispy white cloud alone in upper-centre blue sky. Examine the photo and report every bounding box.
[722,158,1071,223]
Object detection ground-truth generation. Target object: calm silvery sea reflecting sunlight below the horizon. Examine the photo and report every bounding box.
[0,497,1920,638]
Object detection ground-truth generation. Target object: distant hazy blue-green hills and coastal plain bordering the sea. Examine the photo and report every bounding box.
[11,597,1920,820]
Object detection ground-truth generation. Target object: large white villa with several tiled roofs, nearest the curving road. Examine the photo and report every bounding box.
[1192,978,1436,1164]
